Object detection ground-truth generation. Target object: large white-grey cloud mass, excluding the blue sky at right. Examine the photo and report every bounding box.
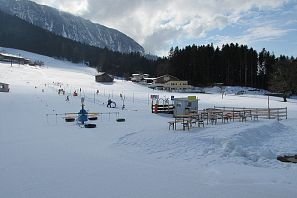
[35,0,289,53]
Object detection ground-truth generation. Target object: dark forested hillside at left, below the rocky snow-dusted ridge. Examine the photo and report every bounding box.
[0,10,156,77]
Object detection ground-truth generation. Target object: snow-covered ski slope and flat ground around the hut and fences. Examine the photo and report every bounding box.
[0,48,297,198]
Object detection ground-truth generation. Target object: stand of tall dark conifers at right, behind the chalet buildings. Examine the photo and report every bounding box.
[156,43,297,97]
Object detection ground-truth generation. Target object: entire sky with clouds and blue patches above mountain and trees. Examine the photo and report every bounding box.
[34,0,297,56]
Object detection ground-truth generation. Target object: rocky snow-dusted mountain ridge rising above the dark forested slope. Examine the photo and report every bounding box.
[0,0,144,54]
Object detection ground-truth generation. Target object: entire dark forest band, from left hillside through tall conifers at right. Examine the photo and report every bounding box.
[0,11,297,95]
